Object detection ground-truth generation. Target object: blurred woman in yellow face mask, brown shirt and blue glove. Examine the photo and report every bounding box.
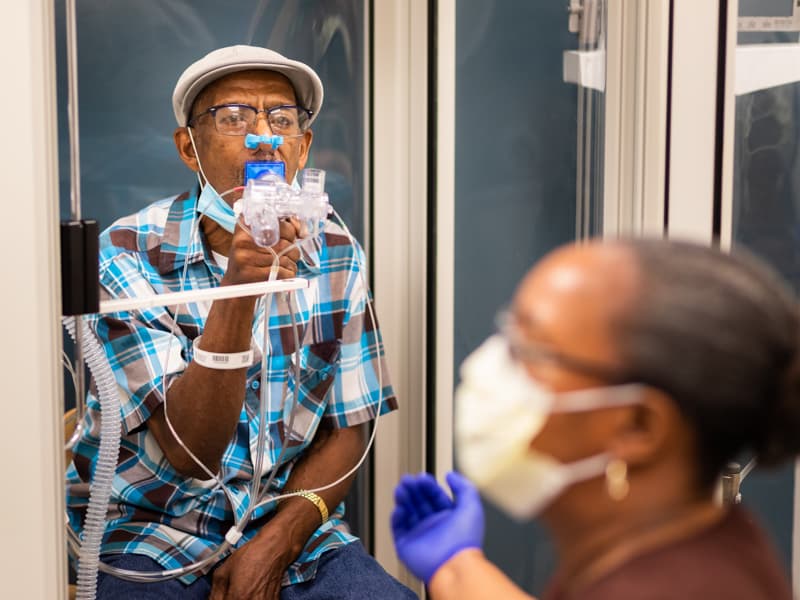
[392,240,800,600]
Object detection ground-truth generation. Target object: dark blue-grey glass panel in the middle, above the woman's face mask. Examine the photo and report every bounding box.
[454,0,602,594]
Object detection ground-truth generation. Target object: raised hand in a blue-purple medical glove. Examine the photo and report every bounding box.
[392,472,484,585]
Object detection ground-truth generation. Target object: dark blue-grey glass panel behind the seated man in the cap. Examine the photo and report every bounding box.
[55,0,371,547]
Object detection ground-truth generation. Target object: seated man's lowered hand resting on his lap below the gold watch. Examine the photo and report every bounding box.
[208,524,296,600]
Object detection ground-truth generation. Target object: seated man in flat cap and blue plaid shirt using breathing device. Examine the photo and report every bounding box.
[67,46,414,600]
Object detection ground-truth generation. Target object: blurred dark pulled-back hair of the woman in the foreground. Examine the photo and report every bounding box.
[618,240,800,484]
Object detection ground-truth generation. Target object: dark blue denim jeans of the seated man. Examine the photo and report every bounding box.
[97,542,417,600]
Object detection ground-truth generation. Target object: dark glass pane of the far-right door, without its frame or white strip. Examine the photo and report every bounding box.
[731,0,800,569]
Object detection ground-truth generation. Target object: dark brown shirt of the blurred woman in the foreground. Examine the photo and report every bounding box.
[543,507,792,600]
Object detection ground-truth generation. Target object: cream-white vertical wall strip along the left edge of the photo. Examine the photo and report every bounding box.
[0,0,66,600]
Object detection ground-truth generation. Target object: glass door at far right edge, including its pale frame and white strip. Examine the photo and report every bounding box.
[721,0,800,591]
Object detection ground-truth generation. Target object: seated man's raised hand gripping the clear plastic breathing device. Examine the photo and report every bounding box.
[222,217,301,285]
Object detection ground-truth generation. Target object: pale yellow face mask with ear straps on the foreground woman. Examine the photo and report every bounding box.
[455,335,642,520]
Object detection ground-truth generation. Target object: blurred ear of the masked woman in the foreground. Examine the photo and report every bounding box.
[609,388,689,467]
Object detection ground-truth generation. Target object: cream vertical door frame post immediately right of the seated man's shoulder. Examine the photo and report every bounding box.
[370,0,430,593]
